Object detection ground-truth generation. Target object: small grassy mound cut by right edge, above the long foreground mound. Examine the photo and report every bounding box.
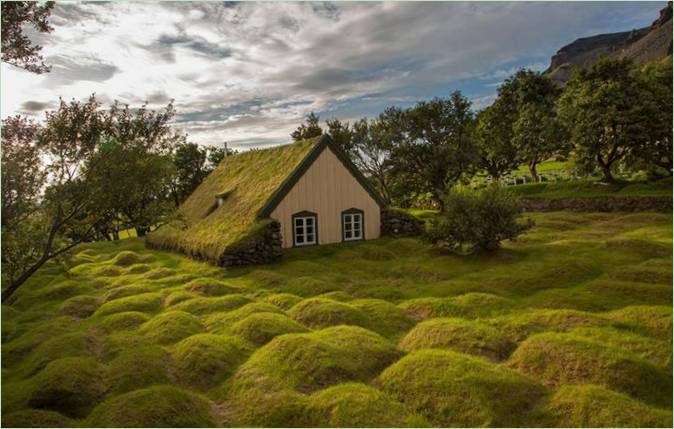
[607,305,672,340]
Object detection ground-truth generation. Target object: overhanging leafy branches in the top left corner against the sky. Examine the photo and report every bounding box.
[2,1,54,74]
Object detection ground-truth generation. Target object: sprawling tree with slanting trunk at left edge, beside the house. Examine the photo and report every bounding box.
[2,96,182,302]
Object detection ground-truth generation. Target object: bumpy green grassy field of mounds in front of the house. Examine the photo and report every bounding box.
[2,212,672,427]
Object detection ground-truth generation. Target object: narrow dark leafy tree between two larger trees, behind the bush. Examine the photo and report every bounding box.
[475,107,520,179]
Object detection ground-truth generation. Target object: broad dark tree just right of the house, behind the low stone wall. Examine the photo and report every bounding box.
[391,91,477,208]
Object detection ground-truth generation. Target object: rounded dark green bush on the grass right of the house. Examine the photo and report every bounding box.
[425,185,532,251]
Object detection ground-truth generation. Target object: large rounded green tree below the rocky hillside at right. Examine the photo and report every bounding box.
[560,59,652,183]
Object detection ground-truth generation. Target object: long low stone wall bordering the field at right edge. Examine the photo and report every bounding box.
[520,196,672,213]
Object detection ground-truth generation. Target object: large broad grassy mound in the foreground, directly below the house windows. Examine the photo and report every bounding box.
[234,326,400,392]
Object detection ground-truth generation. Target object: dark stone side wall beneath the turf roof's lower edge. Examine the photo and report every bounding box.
[219,221,282,267]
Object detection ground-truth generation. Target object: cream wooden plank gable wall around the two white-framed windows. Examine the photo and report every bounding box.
[270,147,380,248]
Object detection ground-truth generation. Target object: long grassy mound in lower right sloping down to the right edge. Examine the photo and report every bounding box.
[509,333,672,406]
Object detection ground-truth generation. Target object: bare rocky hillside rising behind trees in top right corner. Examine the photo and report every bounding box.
[546,2,672,85]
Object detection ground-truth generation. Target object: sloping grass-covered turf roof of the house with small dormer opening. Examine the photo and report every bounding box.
[147,137,320,262]
